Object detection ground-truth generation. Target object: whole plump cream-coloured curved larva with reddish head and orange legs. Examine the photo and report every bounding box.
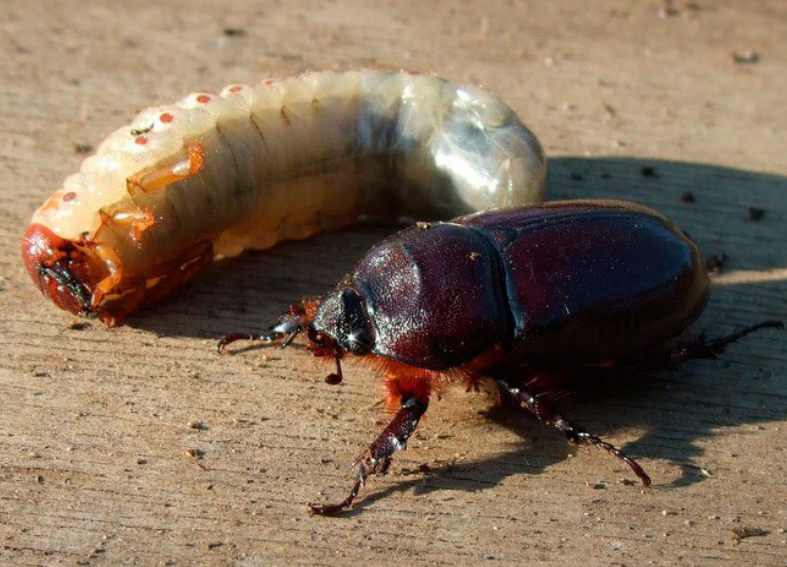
[22,70,546,325]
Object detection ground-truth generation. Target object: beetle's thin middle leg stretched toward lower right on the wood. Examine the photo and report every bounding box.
[495,378,650,486]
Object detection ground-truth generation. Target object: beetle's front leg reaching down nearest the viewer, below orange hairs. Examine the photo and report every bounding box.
[309,398,429,516]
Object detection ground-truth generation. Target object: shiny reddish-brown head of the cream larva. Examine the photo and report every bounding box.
[22,224,92,315]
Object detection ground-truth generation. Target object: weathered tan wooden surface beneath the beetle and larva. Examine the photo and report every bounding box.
[0,0,787,567]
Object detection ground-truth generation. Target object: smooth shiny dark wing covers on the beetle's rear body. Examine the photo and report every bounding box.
[458,201,709,364]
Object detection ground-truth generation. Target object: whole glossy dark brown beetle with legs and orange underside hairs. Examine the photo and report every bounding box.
[219,201,782,514]
